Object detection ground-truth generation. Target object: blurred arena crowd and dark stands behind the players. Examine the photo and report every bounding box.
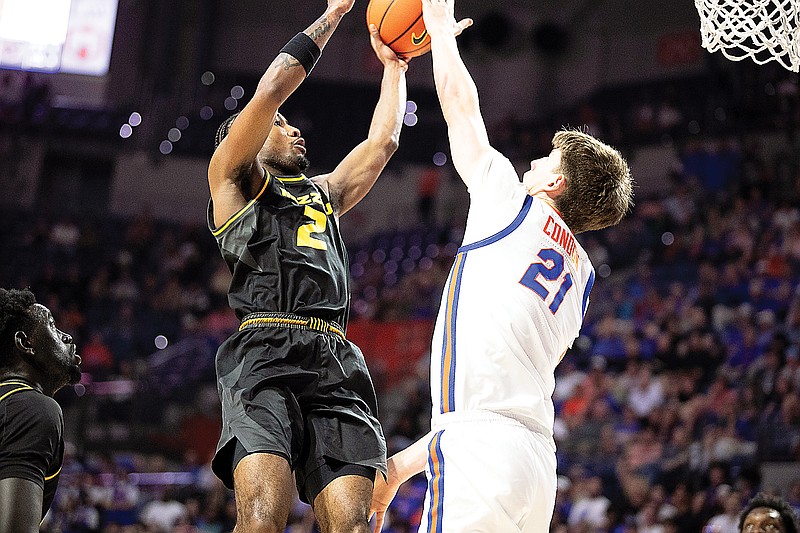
[0,0,800,533]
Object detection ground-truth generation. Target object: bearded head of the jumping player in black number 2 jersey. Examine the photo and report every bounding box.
[214,109,310,175]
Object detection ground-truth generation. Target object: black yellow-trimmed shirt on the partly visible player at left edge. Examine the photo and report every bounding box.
[0,380,64,518]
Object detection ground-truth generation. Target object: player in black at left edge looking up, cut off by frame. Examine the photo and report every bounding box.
[0,289,81,533]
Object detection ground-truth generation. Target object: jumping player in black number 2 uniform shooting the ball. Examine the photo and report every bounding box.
[208,0,407,533]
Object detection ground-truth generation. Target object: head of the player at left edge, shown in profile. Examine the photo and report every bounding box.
[0,289,81,392]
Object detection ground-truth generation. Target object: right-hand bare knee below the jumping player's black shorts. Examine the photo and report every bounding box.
[314,476,372,533]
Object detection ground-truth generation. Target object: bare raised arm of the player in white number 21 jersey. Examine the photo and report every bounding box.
[422,0,484,185]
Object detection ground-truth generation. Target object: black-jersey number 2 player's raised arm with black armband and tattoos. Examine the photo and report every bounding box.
[208,0,355,225]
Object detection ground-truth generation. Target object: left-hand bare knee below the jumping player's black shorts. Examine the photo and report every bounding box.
[233,453,294,533]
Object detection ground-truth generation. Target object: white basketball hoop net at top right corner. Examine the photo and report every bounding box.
[694,0,800,72]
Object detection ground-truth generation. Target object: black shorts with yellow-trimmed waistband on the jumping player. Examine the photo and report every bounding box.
[212,313,386,503]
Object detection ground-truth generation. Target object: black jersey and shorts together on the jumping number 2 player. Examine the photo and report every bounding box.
[208,174,386,502]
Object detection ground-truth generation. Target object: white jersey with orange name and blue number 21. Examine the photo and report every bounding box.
[431,150,594,438]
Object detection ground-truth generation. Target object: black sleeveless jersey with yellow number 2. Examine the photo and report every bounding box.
[208,174,349,326]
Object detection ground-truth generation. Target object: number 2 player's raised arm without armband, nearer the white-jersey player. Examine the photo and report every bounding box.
[317,25,408,215]
